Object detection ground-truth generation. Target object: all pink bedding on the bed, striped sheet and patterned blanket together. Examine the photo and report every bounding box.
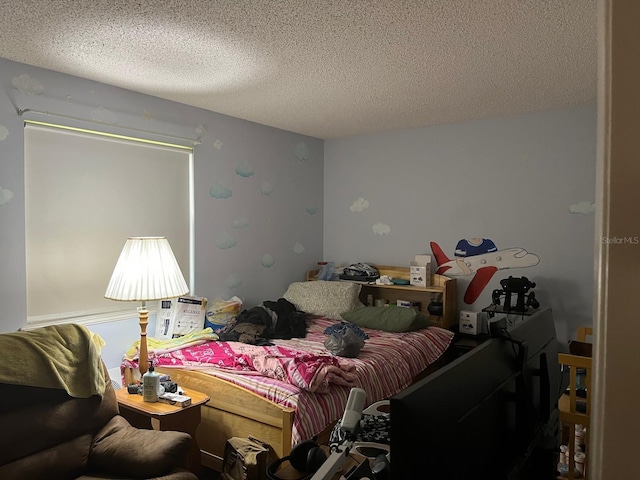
[129,318,453,445]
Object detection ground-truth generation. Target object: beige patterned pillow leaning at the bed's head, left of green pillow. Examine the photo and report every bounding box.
[282,280,362,319]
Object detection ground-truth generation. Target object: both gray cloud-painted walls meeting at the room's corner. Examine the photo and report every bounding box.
[0,54,596,367]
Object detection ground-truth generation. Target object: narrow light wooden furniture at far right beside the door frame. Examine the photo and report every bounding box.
[558,327,593,480]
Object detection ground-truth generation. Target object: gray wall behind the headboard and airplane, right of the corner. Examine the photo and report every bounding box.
[324,106,596,339]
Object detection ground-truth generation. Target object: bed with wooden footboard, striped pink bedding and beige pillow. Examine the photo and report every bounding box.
[125,272,453,471]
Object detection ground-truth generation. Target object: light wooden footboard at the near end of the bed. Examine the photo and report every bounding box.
[125,267,455,471]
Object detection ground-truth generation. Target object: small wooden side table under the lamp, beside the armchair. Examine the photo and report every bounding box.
[116,387,209,475]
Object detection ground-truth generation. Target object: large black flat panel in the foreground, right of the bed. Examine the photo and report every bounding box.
[390,308,561,480]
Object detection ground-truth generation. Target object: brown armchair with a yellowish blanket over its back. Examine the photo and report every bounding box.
[0,325,197,480]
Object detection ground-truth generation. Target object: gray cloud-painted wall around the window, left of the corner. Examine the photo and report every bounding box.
[0,59,323,367]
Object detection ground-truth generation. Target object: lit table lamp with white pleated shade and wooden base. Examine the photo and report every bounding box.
[104,237,189,375]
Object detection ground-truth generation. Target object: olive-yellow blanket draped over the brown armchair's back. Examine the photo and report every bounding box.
[0,324,106,398]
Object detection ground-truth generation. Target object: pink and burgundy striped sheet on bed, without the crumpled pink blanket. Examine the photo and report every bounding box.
[188,317,453,446]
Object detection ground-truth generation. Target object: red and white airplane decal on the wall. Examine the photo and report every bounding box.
[430,242,540,305]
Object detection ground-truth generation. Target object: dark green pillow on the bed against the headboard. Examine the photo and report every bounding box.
[342,307,431,332]
